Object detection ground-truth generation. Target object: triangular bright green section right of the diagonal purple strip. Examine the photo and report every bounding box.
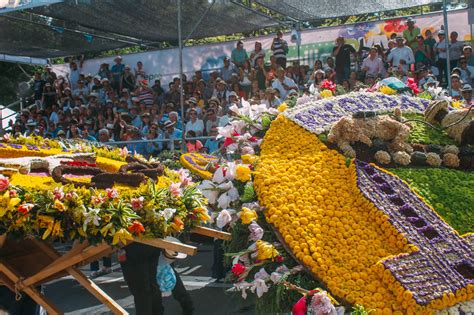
[390,168,474,234]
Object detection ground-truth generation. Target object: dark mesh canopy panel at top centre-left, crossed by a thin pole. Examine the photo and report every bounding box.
[32,0,276,41]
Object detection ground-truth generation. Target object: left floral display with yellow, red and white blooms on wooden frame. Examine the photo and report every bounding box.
[0,138,211,245]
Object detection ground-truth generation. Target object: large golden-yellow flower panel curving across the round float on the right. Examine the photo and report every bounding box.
[254,116,413,312]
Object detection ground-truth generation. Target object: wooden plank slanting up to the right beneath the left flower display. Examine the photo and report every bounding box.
[23,243,109,286]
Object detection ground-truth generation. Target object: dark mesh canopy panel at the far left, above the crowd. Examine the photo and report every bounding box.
[0,14,126,58]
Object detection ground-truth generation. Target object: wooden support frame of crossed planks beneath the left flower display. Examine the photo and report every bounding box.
[0,227,230,315]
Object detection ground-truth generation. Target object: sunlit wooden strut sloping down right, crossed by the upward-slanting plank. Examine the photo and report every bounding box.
[32,241,128,315]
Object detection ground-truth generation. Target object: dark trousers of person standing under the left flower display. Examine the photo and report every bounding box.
[120,243,164,315]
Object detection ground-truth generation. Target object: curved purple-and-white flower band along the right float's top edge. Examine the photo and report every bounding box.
[284,92,429,134]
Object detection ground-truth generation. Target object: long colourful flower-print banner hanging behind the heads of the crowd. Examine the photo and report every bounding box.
[55,10,471,88]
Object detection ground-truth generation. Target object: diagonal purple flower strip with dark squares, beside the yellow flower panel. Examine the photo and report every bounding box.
[356,160,474,305]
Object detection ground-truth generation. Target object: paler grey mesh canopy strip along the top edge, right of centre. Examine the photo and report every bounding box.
[256,0,441,21]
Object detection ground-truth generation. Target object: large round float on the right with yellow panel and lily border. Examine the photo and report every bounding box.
[180,90,474,314]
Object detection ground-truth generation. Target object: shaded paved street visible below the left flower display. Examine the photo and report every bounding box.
[45,245,254,315]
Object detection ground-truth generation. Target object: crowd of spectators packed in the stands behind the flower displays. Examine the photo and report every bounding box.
[11,18,474,156]
